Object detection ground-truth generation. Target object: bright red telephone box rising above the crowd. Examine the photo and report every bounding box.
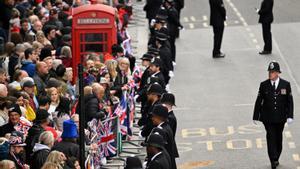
[72,4,117,79]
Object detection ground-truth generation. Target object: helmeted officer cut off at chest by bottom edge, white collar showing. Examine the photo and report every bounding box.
[146,133,171,169]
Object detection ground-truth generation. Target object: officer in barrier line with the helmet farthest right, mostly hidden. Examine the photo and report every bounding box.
[160,93,177,138]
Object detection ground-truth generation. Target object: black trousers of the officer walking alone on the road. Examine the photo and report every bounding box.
[264,123,285,162]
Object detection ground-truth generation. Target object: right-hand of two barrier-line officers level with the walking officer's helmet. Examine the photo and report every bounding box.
[147,58,166,89]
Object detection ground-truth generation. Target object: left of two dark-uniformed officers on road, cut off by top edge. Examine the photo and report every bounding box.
[209,0,226,58]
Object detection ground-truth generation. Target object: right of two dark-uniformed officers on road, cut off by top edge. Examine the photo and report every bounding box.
[257,0,274,55]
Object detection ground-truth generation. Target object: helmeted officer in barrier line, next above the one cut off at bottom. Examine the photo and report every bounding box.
[151,104,179,169]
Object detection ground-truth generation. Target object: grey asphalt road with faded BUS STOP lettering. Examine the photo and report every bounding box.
[171,0,300,169]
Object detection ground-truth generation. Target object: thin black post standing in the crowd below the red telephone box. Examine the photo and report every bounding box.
[78,62,85,168]
